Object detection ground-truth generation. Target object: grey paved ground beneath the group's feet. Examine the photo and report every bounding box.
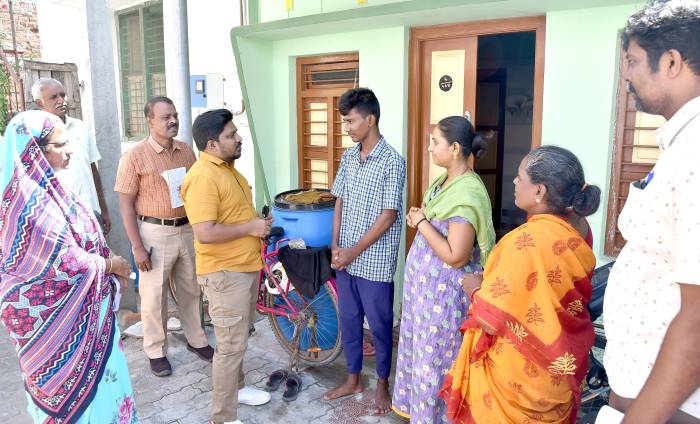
[0,319,404,424]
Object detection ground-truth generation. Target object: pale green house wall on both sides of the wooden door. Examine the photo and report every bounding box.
[234,0,644,282]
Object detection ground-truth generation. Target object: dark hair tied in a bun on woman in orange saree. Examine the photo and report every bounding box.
[525,145,600,216]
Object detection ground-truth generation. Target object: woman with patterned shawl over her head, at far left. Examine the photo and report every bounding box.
[0,111,138,424]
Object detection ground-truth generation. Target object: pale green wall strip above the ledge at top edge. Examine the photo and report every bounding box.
[260,0,405,22]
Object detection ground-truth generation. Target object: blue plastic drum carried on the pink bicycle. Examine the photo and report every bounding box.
[272,189,335,247]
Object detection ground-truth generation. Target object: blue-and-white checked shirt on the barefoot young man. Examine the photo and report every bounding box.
[331,137,406,282]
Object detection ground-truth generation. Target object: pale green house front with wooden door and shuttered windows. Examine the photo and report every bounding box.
[231,0,660,274]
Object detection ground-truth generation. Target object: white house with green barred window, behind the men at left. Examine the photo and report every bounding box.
[34,0,254,309]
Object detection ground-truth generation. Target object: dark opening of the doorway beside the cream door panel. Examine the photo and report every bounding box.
[474,31,535,238]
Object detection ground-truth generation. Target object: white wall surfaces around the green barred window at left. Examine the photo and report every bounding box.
[37,0,255,187]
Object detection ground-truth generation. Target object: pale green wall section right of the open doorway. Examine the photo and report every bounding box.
[542,3,643,261]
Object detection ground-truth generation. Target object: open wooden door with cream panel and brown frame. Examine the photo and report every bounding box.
[406,16,545,245]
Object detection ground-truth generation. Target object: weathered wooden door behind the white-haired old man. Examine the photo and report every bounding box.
[23,60,83,119]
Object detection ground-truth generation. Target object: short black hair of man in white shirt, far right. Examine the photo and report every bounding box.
[622,0,700,75]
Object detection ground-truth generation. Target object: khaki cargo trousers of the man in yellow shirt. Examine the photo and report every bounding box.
[197,271,258,423]
